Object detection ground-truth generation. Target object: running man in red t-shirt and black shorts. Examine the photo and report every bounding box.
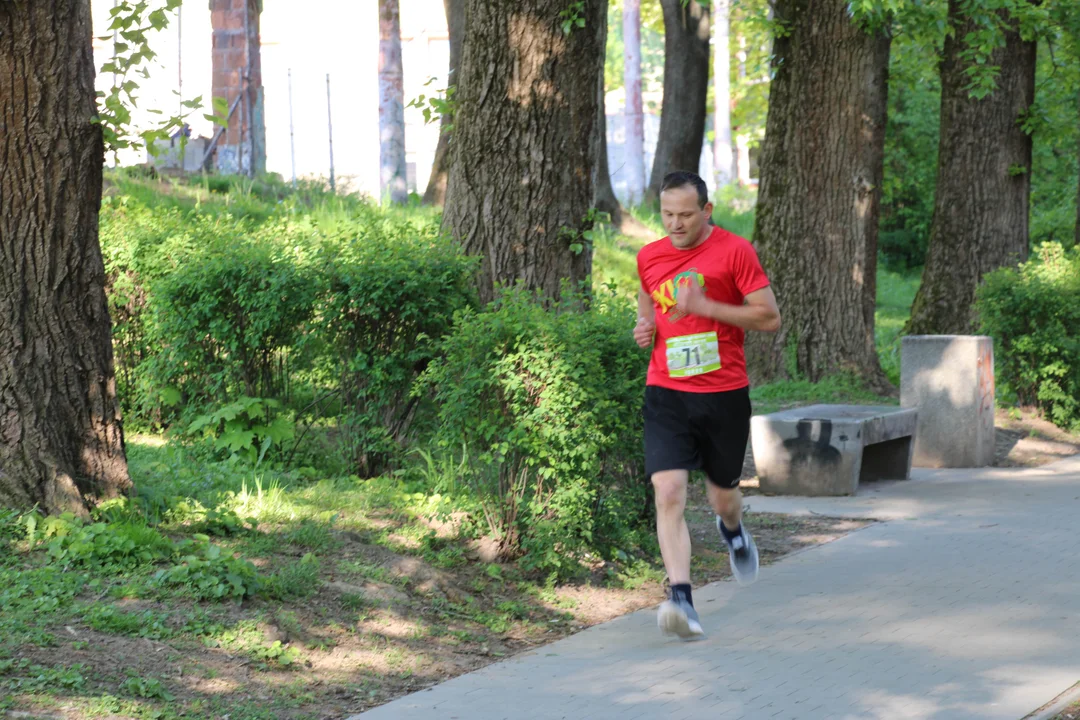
[634,172,780,639]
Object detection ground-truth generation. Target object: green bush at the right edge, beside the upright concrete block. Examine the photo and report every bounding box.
[976,243,1080,429]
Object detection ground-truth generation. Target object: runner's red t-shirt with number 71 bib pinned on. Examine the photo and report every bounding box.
[637,228,769,393]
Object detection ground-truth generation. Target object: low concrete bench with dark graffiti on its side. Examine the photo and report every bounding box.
[751,405,918,495]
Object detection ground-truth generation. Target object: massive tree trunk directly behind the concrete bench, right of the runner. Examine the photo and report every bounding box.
[747,0,889,389]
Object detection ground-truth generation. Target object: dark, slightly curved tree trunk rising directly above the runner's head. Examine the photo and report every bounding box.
[646,0,712,203]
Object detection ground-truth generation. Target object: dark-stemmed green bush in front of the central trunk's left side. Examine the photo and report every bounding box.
[315,208,476,476]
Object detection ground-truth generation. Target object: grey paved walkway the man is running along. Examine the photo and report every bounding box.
[356,456,1080,720]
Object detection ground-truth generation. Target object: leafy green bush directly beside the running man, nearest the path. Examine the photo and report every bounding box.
[418,289,648,575]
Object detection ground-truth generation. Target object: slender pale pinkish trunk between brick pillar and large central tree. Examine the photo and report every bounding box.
[379,0,408,205]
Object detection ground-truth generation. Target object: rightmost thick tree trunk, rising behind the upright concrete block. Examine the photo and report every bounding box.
[905,0,1036,335]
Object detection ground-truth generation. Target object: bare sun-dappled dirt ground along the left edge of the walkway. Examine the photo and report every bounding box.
[0,511,867,720]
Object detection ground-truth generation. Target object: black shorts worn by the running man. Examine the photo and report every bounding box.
[645,385,751,488]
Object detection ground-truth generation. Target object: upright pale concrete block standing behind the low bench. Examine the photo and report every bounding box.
[900,335,995,467]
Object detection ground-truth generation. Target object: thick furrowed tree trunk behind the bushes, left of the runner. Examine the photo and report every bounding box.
[443,0,607,300]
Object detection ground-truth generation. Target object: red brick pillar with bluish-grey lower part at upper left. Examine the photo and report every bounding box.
[210,0,267,175]
